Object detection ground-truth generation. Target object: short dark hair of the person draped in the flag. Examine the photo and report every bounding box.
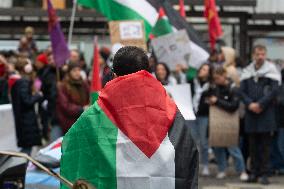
[113,46,149,76]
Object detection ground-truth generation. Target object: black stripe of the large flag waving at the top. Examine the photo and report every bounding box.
[159,0,207,50]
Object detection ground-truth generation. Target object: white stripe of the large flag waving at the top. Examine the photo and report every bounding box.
[114,0,158,26]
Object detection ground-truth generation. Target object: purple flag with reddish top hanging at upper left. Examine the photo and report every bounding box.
[47,0,70,67]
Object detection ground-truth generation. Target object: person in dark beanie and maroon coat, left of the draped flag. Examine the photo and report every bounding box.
[56,63,89,134]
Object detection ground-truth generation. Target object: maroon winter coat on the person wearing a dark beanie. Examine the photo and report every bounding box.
[56,78,89,134]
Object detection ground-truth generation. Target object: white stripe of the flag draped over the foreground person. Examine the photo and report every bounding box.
[116,131,175,189]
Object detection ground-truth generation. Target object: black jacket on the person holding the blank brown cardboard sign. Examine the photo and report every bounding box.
[210,82,239,112]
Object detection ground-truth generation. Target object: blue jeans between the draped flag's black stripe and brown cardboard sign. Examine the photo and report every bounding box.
[191,116,208,166]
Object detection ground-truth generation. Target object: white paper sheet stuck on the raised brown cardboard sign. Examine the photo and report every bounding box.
[119,21,144,40]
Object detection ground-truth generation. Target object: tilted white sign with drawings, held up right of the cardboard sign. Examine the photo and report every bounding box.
[152,30,203,70]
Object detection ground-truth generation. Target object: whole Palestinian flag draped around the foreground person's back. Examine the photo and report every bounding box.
[61,71,198,189]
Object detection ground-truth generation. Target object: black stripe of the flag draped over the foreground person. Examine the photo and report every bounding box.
[169,112,198,189]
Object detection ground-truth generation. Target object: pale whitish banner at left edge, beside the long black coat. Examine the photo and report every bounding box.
[0,104,17,150]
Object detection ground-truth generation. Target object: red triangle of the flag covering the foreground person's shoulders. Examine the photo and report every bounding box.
[98,71,177,158]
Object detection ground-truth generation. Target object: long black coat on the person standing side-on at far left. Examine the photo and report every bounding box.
[11,78,42,148]
